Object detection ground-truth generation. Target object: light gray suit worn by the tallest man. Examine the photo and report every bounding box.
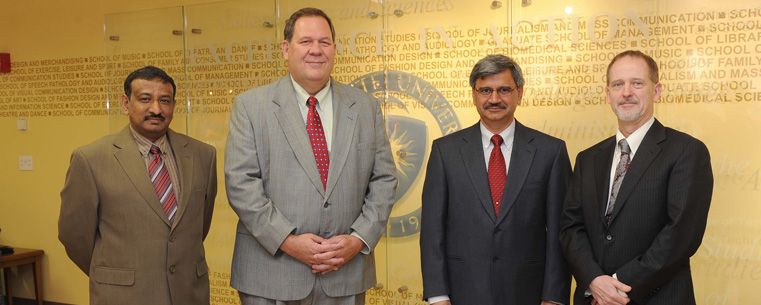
[225,75,396,300]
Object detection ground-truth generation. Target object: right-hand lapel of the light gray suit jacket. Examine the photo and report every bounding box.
[325,80,356,200]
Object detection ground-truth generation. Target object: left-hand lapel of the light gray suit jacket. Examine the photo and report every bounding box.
[272,75,330,195]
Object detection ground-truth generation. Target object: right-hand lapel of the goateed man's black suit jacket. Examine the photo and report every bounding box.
[611,120,666,222]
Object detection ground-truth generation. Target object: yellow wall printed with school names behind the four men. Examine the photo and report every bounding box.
[0,0,761,305]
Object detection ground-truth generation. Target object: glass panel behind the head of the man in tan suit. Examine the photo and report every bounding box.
[103,7,187,133]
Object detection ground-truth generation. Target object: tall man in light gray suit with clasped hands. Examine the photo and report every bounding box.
[225,8,396,304]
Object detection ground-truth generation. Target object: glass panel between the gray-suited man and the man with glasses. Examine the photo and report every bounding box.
[382,0,511,304]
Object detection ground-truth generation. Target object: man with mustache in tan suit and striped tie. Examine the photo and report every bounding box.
[58,66,217,305]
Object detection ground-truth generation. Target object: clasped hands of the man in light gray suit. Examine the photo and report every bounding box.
[280,233,344,267]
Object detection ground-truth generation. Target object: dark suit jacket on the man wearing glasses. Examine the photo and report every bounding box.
[420,121,571,305]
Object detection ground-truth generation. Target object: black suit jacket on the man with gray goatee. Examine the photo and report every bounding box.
[561,120,713,304]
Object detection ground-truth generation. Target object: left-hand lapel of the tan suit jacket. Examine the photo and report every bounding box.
[113,126,169,226]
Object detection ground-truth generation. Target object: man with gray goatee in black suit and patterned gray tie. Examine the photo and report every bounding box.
[560,51,713,305]
